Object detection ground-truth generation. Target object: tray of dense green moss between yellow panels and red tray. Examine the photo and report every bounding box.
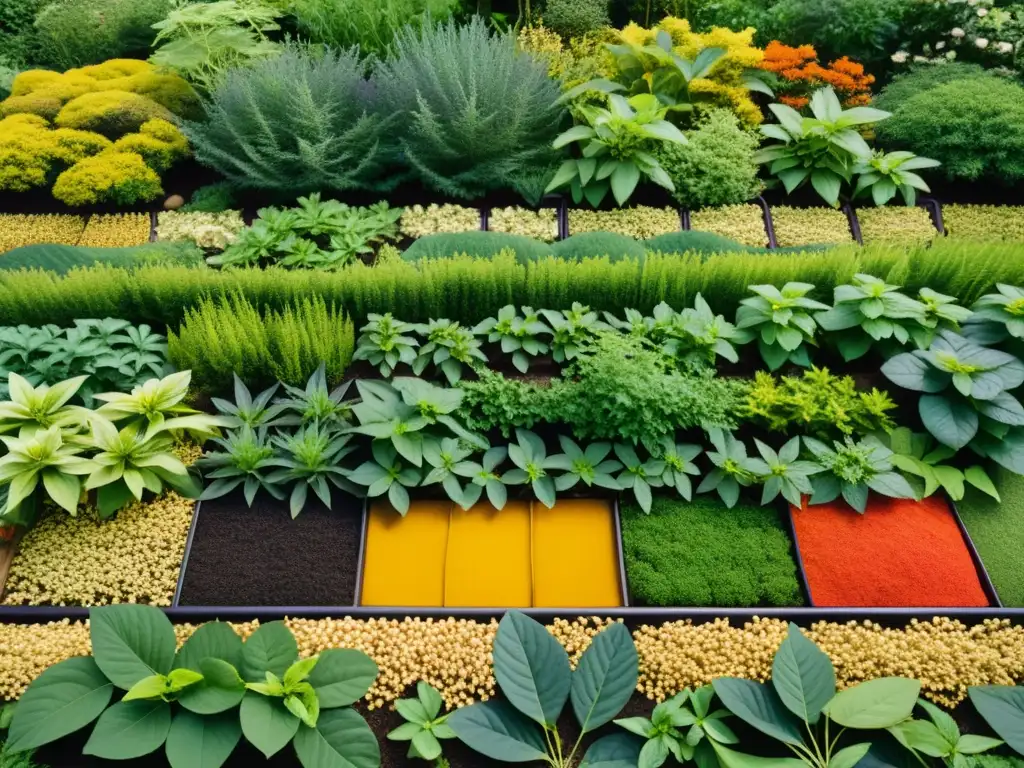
[623,497,804,607]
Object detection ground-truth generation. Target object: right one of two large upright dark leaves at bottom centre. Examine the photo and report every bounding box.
[569,624,638,733]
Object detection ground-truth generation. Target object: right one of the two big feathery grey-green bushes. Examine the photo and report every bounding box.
[374,16,565,202]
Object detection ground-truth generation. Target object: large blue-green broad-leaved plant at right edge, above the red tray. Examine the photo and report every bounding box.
[882,331,1024,469]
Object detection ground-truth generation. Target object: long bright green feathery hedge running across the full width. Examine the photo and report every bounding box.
[0,240,1024,327]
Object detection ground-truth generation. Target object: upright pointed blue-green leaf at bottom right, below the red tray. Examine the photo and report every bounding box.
[771,623,836,725]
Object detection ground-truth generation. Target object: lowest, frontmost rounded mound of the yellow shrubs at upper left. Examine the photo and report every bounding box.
[53,150,164,206]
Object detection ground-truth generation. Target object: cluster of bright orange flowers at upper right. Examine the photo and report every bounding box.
[759,40,874,110]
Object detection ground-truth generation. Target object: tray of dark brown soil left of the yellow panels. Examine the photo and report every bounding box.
[178,492,362,606]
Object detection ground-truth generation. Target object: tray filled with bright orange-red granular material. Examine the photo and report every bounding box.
[793,494,988,608]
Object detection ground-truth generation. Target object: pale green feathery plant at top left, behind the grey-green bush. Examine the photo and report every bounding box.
[150,0,282,92]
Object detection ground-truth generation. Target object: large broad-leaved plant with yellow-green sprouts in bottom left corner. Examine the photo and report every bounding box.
[7,605,380,768]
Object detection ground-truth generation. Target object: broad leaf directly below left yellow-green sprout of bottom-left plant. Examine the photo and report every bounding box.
[82,701,171,760]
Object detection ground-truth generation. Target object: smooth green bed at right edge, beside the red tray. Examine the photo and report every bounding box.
[956,468,1024,608]
